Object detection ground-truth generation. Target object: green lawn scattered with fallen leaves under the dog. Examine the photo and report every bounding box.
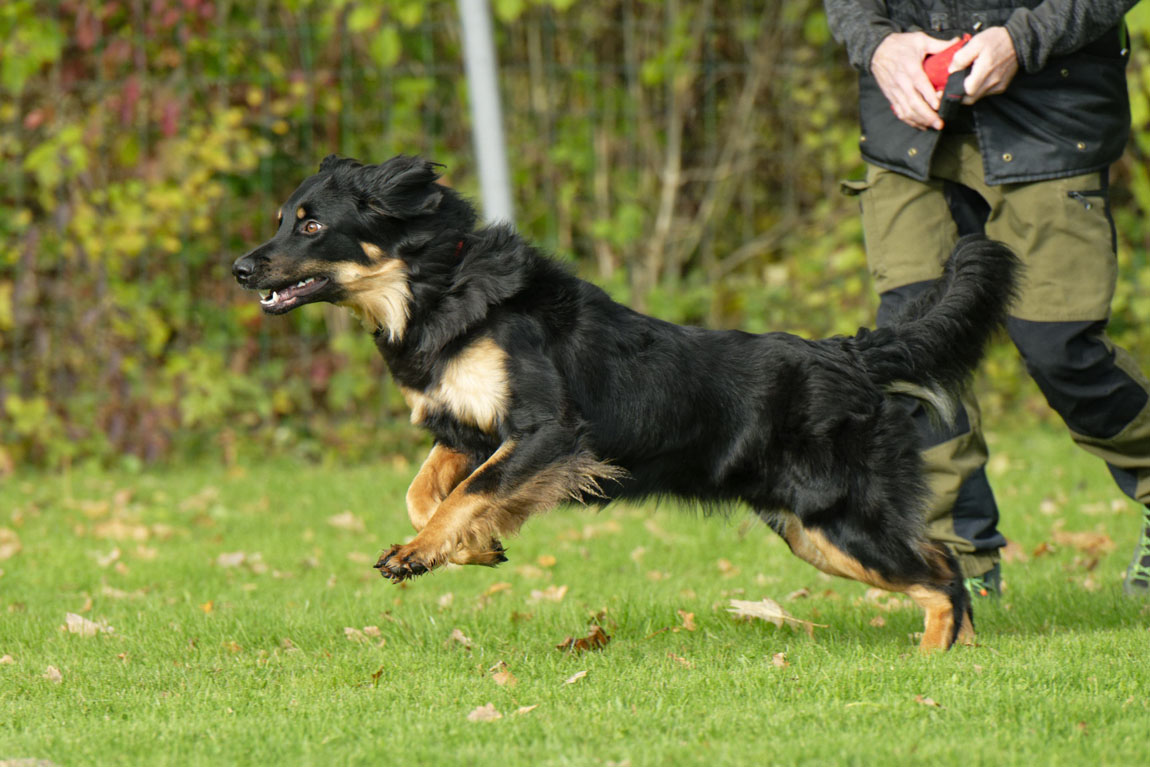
[0,430,1150,767]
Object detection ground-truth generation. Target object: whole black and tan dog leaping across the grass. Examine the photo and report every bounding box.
[233,156,1017,649]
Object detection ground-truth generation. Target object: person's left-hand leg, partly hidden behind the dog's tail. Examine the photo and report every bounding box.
[861,167,1006,577]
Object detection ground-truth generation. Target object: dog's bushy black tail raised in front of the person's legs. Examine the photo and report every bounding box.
[856,235,1020,399]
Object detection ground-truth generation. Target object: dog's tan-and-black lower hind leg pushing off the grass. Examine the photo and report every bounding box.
[771,513,974,652]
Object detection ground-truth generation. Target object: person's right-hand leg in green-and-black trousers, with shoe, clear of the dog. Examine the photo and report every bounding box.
[987,172,1150,593]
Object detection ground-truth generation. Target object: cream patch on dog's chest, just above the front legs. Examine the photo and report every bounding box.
[400,338,509,431]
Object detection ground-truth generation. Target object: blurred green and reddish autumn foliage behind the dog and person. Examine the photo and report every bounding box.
[0,0,1150,474]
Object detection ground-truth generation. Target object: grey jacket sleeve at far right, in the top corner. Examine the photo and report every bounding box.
[1007,0,1139,72]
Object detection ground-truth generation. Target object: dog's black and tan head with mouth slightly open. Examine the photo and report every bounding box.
[232,155,475,336]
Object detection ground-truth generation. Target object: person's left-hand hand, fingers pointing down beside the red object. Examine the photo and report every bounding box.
[871,32,956,130]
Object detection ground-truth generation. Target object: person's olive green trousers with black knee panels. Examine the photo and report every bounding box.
[852,133,1150,577]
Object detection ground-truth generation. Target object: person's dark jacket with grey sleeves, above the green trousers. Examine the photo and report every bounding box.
[825,0,1137,184]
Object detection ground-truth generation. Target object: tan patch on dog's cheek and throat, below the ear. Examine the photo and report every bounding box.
[335,243,412,342]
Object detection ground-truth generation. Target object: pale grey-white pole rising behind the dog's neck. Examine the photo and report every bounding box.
[459,0,515,223]
